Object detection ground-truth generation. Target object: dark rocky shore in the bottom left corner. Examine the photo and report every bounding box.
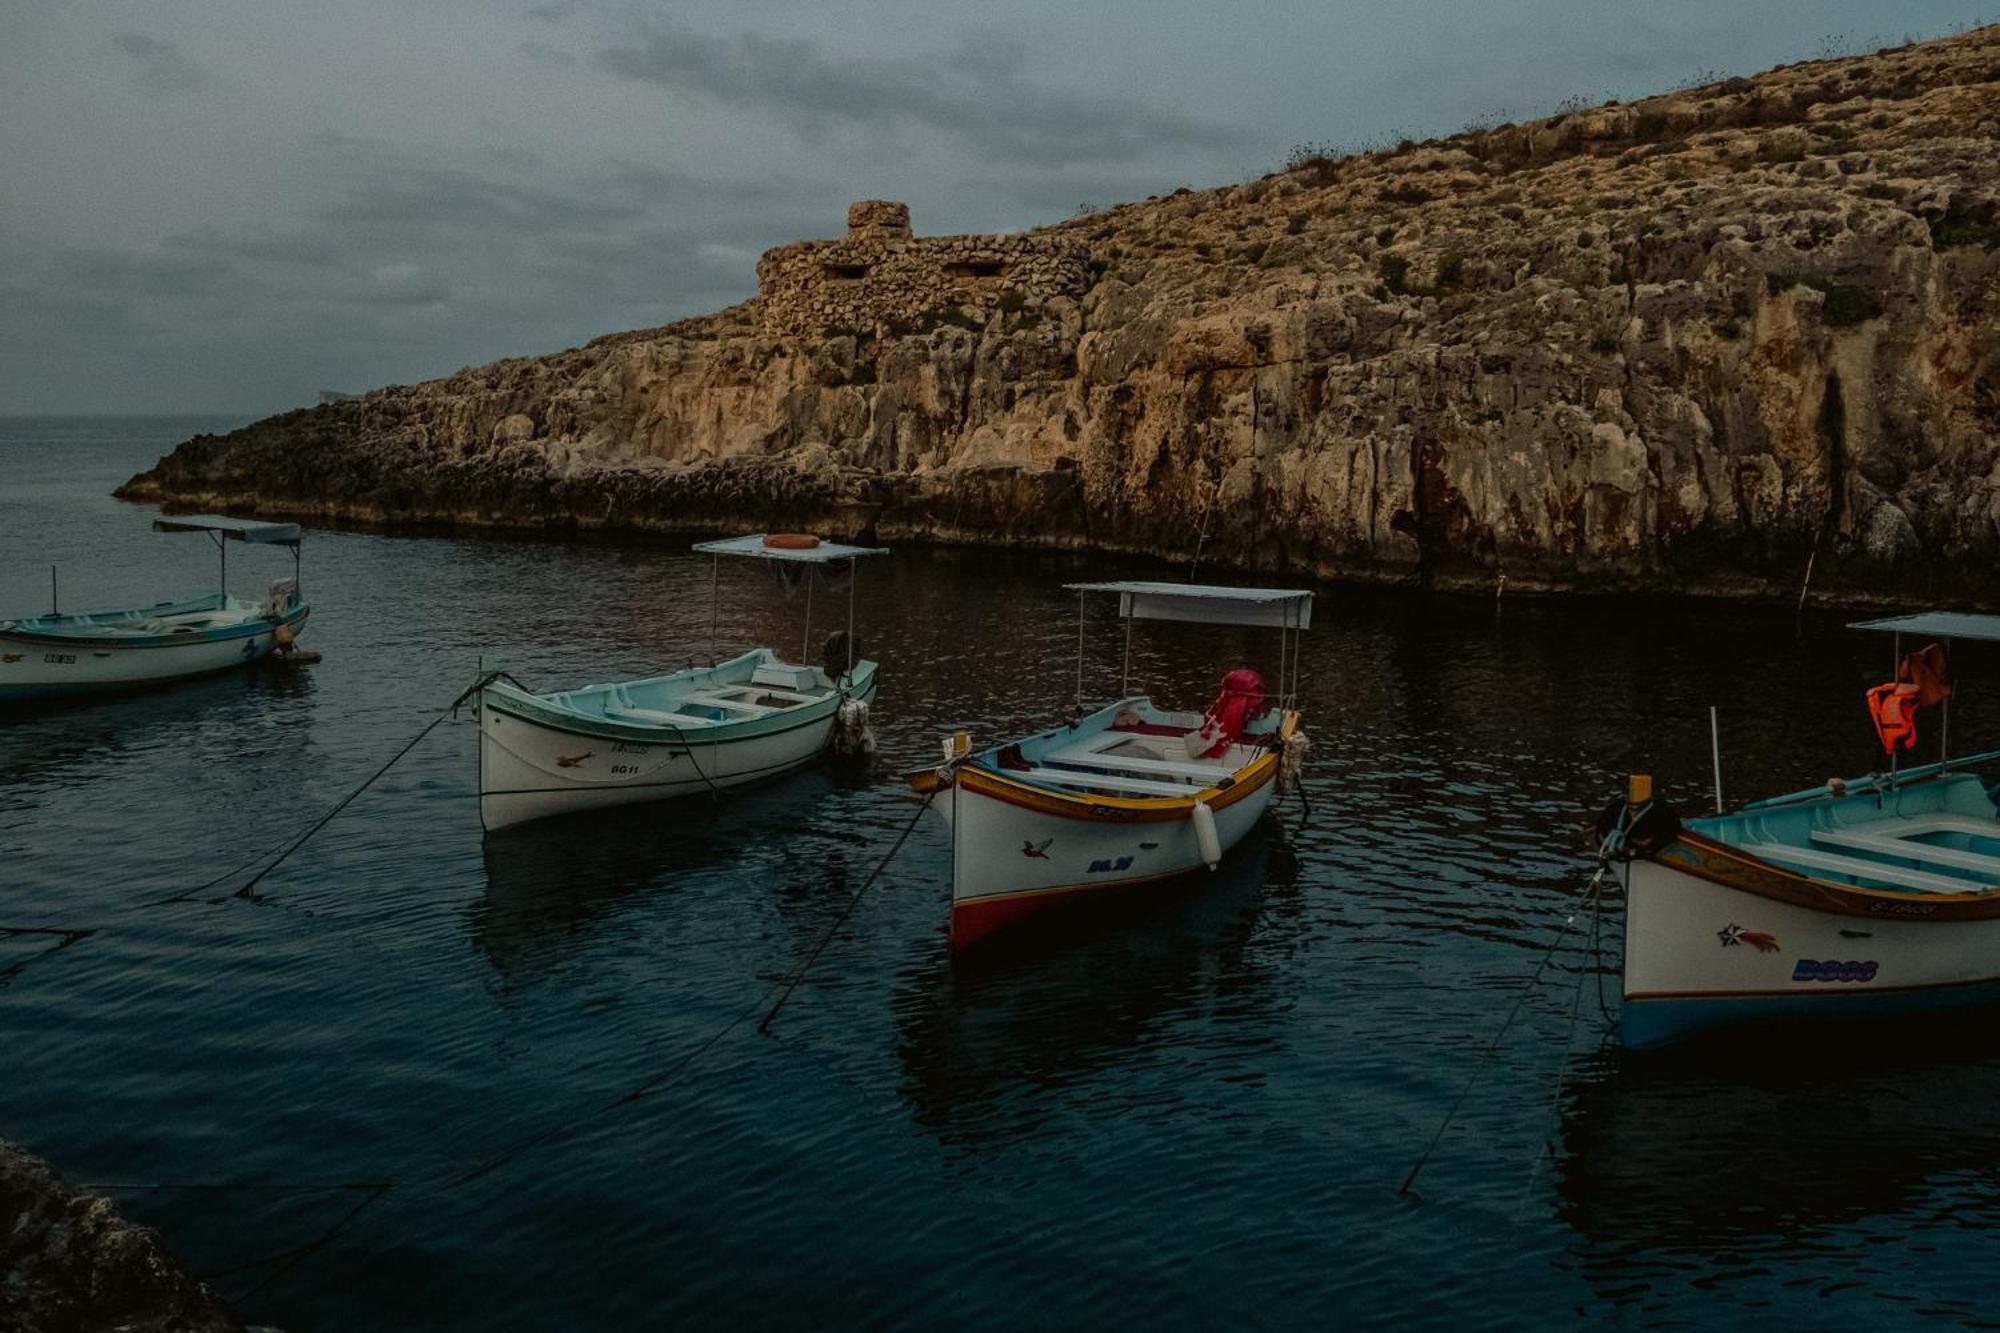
[0,1143,274,1333]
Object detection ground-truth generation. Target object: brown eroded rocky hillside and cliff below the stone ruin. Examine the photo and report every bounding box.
[120,28,2000,600]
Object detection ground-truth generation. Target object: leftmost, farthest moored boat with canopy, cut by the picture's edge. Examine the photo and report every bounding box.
[0,514,310,703]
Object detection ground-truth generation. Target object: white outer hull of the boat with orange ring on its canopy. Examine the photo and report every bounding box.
[478,664,876,831]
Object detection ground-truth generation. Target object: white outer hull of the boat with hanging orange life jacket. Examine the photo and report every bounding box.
[1620,843,2000,1051]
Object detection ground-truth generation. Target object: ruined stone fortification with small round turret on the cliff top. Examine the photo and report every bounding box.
[756,198,1090,338]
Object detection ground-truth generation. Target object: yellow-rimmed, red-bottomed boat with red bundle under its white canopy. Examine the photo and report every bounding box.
[908,582,1312,949]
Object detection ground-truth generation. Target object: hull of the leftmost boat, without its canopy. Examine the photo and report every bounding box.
[0,606,310,705]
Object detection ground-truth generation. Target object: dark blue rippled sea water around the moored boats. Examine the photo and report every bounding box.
[0,418,2000,1333]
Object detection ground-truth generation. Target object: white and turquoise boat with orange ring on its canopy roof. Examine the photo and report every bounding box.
[480,534,886,831]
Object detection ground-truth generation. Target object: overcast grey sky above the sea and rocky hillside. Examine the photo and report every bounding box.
[0,0,1990,412]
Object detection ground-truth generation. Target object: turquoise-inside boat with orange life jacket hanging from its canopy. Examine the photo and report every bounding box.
[1608,612,2000,1049]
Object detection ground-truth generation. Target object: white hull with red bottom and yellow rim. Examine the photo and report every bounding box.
[934,755,1278,949]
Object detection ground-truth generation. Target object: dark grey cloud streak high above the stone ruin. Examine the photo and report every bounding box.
[590,20,1244,166]
